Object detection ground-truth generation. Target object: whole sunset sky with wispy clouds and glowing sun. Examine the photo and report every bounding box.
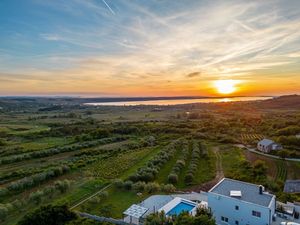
[0,0,300,96]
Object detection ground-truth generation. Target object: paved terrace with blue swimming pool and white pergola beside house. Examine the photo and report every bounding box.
[123,192,207,224]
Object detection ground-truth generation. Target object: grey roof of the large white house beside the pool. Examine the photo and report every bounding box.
[209,178,274,207]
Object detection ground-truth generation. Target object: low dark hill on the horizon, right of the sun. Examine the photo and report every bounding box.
[255,95,300,109]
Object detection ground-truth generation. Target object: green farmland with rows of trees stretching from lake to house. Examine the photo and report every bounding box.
[0,96,300,225]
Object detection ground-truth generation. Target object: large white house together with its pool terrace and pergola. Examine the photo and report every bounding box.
[123,178,276,225]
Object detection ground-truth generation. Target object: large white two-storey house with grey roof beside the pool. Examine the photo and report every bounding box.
[208,178,275,225]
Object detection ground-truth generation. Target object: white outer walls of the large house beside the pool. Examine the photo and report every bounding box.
[208,192,273,225]
